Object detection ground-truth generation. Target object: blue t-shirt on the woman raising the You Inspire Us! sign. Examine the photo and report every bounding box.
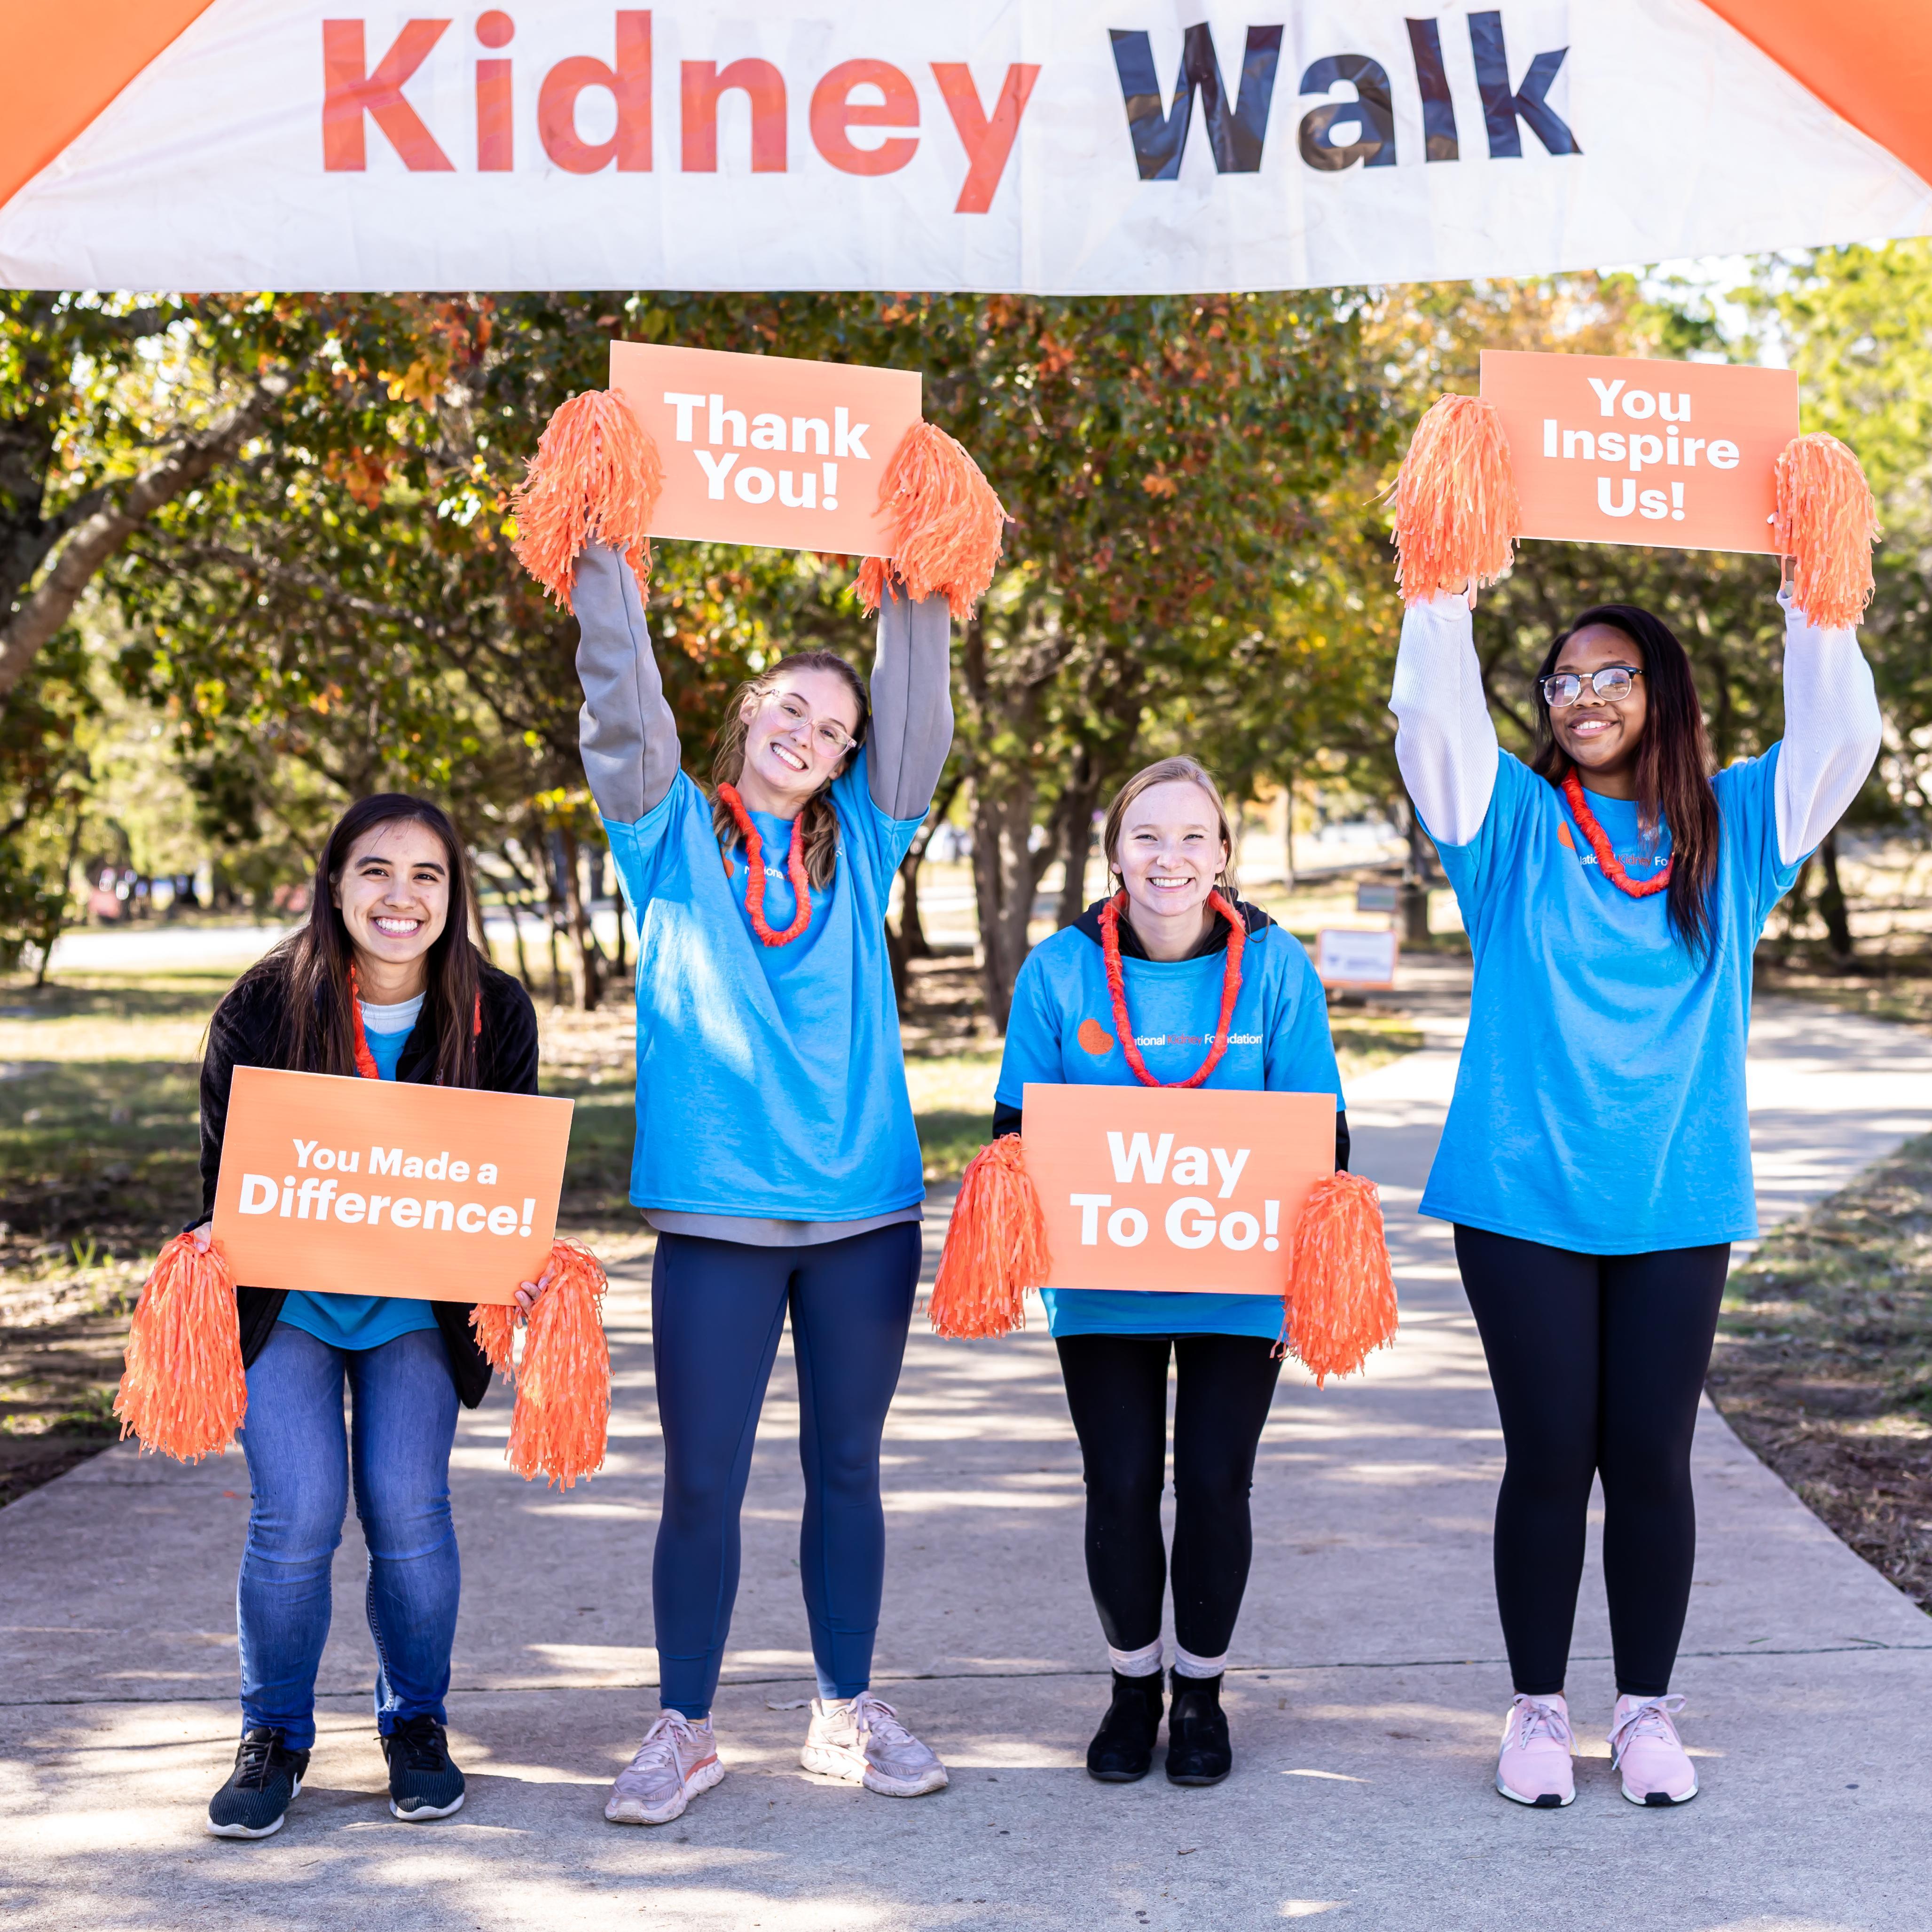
[1422,746,1803,1254]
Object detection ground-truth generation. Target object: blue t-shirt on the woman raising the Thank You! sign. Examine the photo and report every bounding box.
[605,752,926,1221]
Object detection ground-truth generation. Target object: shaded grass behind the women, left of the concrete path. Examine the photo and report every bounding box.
[0,952,1422,1503]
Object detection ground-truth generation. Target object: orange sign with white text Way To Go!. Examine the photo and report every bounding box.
[1022,1082,1335,1295]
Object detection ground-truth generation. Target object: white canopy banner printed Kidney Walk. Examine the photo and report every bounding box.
[0,0,1932,294]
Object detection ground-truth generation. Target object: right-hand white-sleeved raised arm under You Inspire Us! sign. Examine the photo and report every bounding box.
[1777,585,1882,865]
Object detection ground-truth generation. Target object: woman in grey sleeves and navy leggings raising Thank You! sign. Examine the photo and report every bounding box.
[533,545,952,1824]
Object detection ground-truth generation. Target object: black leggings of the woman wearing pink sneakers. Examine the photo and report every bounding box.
[1455,1227,1731,1696]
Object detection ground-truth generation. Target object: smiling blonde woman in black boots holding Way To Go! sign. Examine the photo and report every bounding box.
[993,757,1349,1785]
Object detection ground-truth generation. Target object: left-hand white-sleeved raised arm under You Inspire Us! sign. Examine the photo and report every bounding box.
[1389,597,1497,844]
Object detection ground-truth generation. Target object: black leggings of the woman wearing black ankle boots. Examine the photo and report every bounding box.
[1059,1335,1281,1657]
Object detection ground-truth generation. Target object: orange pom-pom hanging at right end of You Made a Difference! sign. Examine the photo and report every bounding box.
[504,1239,611,1490]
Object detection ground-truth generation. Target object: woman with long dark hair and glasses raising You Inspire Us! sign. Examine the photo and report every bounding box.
[1389,591,1880,1806]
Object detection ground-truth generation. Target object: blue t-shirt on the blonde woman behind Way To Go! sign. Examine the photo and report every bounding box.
[995,926,1341,1341]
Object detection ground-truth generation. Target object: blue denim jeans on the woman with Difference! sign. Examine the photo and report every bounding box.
[236,1321,462,1751]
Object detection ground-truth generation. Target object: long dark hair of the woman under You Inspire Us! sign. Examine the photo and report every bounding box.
[1530,605,1718,952]
